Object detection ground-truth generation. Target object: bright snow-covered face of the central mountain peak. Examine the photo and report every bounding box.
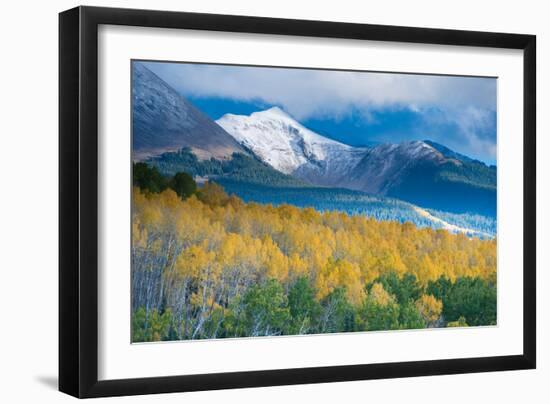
[216,107,368,185]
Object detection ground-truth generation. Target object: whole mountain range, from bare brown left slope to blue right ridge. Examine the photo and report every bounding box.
[133,63,496,217]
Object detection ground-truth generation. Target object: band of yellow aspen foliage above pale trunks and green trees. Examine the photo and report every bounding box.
[132,184,496,293]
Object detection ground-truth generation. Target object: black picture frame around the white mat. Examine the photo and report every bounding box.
[59,7,536,398]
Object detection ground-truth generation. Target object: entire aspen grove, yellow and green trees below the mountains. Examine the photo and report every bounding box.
[131,169,497,342]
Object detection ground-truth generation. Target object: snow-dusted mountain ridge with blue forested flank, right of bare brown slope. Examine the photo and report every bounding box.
[216,107,496,216]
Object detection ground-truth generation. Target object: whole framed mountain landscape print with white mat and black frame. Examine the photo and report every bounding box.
[59,7,536,397]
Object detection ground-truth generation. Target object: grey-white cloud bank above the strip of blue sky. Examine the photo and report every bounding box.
[142,62,496,160]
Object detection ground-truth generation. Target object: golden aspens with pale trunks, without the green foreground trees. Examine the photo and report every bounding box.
[132,184,496,339]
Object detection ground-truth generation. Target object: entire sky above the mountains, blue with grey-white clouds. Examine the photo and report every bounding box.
[141,62,496,164]
